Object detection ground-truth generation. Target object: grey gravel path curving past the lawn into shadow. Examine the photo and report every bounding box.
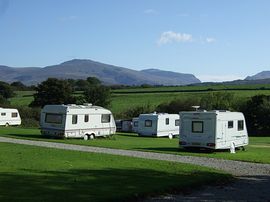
[0,137,270,201]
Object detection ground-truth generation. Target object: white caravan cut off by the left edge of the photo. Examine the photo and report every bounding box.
[0,107,22,126]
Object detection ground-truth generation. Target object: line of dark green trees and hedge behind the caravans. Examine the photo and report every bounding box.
[0,77,270,136]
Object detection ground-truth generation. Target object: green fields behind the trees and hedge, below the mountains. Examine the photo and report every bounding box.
[10,84,270,114]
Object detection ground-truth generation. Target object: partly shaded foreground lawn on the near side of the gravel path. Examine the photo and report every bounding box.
[0,143,231,201]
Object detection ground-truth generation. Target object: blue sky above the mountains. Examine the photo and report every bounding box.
[0,0,270,81]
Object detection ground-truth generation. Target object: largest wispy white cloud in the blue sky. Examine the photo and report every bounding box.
[157,31,193,45]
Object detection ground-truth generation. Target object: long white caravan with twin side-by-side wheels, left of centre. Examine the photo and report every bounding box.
[40,104,116,140]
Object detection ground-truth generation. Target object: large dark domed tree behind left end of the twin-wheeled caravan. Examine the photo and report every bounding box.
[30,78,75,107]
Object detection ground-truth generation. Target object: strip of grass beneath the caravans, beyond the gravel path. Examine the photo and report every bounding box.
[0,127,270,163]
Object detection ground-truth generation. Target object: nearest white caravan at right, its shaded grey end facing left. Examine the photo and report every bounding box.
[179,110,248,149]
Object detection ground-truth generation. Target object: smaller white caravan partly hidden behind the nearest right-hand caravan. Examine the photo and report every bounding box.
[138,112,179,139]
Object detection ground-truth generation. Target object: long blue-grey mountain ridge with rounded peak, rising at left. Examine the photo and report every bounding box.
[0,59,201,85]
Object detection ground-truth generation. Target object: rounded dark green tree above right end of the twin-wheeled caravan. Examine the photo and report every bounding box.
[83,85,111,107]
